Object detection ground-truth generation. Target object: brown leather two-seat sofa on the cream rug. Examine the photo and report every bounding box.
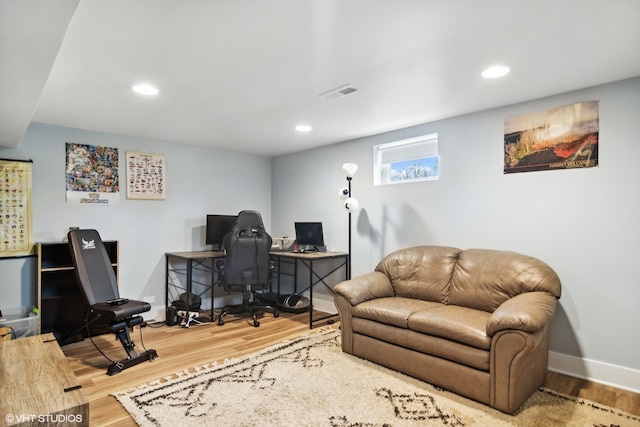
[334,246,560,414]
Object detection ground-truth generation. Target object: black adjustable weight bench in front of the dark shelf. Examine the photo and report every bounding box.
[68,229,158,375]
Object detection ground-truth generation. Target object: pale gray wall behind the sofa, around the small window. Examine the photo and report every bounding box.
[272,78,640,390]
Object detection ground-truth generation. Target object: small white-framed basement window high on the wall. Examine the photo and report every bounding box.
[373,133,440,185]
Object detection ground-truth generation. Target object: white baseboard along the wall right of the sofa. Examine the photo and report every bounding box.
[549,351,640,393]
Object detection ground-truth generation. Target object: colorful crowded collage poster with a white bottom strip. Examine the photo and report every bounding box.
[65,142,120,205]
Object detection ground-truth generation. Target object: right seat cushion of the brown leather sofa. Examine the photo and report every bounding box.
[408,304,491,350]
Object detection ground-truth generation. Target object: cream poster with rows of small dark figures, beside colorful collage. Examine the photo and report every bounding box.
[127,152,165,200]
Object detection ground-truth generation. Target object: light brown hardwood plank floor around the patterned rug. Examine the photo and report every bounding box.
[62,313,640,427]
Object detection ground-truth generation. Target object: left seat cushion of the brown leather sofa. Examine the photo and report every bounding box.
[351,297,442,328]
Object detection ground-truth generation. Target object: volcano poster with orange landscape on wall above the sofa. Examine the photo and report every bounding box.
[504,101,600,174]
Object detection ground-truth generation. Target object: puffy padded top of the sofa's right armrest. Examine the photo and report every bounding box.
[487,292,558,337]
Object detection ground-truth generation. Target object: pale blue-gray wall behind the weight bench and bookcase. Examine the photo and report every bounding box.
[0,123,271,316]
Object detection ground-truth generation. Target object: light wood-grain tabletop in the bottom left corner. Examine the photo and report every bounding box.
[0,333,89,426]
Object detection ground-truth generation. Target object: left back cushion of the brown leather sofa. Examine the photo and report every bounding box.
[376,246,461,304]
